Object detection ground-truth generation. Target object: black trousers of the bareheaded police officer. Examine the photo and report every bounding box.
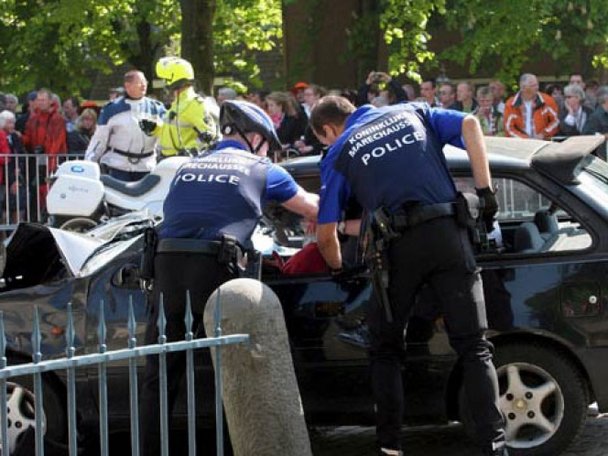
[368,217,505,450]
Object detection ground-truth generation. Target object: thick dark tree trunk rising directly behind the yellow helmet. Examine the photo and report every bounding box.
[179,0,216,94]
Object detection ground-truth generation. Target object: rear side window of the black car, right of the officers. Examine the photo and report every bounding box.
[454,177,592,255]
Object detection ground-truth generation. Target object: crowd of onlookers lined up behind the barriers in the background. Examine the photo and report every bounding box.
[0,71,608,226]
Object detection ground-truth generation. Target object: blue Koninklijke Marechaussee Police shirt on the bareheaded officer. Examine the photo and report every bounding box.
[318,103,466,223]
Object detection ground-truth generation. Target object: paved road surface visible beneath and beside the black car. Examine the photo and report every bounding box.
[311,414,608,456]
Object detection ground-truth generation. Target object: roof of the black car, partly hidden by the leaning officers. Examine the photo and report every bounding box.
[281,135,604,184]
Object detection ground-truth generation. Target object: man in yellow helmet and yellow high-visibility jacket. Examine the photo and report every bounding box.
[140,57,217,158]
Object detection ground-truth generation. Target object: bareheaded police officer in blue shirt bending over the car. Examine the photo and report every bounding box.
[310,96,507,456]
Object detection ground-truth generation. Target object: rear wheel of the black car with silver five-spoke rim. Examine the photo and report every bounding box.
[459,343,589,456]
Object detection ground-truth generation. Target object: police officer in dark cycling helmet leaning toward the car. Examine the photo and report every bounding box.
[142,101,318,456]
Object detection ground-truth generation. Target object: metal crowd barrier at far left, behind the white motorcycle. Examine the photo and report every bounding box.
[0,154,84,231]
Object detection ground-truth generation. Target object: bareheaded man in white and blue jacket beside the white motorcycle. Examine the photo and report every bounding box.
[85,70,165,182]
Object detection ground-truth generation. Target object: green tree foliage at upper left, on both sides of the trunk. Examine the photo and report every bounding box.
[0,0,282,95]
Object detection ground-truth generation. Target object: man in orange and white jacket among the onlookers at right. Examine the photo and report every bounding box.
[504,73,559,139]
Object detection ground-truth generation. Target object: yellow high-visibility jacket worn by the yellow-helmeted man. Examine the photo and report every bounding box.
[154,87,216,157]
